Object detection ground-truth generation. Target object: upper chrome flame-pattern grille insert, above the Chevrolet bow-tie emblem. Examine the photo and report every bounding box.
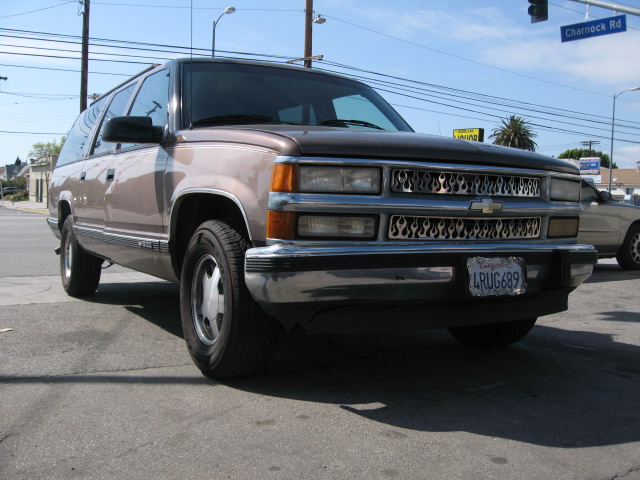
[391,168,540,197]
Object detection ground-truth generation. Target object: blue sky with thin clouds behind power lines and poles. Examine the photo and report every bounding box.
[0,0,640,168]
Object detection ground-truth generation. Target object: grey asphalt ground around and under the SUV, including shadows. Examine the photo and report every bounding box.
[0,208,640,480]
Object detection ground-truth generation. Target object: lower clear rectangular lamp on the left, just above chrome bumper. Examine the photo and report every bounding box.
[298,215,376,239]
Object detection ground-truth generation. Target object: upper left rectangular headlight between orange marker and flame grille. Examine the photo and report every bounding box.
[298,166,380,194]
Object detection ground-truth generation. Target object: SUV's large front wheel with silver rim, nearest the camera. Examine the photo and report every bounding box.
[180,220,279,379]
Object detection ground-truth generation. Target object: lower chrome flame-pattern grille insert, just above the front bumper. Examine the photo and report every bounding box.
[389,215,541,240]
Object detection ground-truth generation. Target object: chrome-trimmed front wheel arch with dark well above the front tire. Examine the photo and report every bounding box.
[169,189,253,278]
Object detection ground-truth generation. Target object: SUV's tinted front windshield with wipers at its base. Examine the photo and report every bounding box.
[182,62,412,131]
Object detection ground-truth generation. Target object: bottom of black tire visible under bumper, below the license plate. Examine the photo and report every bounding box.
[448,318,537,348]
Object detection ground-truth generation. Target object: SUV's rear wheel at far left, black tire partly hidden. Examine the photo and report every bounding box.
[60,216,103,297]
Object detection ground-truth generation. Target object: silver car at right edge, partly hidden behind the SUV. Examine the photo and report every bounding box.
[578,180,640,270]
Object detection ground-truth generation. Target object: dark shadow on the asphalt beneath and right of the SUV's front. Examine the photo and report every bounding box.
[228,326,640,448]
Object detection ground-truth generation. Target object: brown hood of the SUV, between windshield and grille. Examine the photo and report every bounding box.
[178,125,579,174]
